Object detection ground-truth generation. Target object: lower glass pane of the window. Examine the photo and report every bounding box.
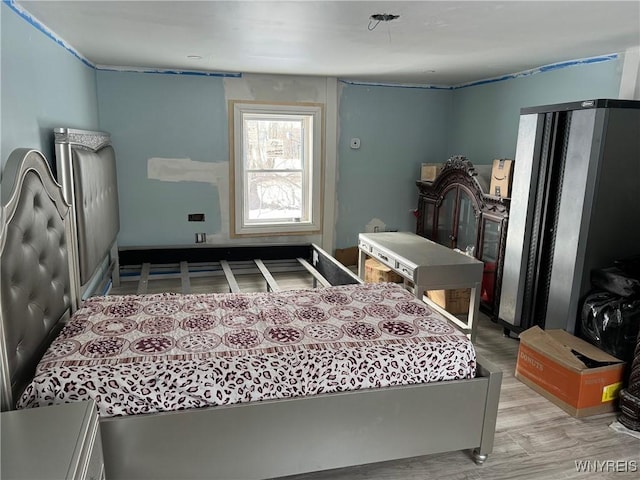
[245,172,308,223]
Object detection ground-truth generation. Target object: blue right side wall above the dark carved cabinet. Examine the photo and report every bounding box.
[448,58,623,164]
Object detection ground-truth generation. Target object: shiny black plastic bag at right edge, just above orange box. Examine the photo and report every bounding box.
[580,291,640,362]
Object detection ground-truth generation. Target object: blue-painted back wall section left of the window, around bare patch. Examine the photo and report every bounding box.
[98,71,229,245]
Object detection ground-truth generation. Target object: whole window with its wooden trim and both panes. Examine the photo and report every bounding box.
[231,102,322,235]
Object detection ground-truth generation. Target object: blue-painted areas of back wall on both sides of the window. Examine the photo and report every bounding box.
[98,71,452,248]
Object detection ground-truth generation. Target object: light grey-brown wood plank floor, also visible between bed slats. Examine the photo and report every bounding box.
[112,268,640,480]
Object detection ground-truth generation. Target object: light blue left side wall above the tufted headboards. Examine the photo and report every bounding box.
[0,3,98,171]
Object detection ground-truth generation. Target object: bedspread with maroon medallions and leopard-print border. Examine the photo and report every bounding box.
[18,283,476,417]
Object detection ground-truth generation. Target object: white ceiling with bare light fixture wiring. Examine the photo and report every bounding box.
[15,0,640,85]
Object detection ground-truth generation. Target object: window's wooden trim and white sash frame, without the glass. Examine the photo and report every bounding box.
[229,100,324,237]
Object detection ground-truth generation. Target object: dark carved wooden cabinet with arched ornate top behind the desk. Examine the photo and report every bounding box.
[416,156,509,319]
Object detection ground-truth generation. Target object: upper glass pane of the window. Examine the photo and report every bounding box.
[244,115,303,170]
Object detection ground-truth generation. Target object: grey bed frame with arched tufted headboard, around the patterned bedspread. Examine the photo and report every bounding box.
[0,150,502,480]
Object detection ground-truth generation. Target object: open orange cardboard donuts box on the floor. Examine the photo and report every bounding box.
[515,326,624,418]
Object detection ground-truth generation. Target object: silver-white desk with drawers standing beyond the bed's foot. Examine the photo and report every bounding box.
[358,232,484,341]
